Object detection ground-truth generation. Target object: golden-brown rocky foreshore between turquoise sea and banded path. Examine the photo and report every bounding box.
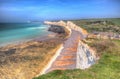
[0,39,61,79]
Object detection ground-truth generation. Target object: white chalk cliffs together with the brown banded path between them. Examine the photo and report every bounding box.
[44,21,96,73]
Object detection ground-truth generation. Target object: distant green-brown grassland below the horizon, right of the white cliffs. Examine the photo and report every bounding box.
[72,18,120,34]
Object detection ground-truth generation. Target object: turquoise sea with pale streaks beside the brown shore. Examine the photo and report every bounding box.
[0,23,49,46]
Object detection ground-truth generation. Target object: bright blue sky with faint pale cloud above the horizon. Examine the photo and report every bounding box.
[0,0,120,22]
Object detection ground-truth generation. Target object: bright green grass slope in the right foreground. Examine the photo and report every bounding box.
[34,40,120,79]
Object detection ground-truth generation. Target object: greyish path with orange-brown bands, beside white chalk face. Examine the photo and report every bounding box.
[45,30,82,73]
